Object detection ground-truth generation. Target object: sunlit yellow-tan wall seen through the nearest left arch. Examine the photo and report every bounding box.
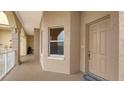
[0,29,12,50]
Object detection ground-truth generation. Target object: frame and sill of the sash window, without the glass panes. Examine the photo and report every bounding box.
[48,26,65,60]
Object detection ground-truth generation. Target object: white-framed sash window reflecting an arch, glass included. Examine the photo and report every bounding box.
[49,27,64,57]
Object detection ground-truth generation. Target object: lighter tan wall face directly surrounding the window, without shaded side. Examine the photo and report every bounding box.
[41,12,70,74]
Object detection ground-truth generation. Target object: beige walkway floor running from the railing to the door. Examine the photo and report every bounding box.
[3,55,83,81]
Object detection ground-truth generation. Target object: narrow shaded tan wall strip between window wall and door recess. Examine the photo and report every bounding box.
[70,12,81,73]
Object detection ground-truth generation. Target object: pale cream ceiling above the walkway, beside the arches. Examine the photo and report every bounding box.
[15,11,43,35]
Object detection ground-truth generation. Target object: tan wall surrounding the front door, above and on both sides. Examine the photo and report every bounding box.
[80,12,119,80]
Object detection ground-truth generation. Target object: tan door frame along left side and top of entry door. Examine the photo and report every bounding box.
[85,14,111,78]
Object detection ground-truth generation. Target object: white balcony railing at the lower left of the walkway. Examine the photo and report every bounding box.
[0,50,16,80]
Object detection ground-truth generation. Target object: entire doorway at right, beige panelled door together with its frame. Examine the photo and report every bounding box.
[86,15,113,80]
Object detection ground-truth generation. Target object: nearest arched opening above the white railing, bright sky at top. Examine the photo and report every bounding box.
[0,11,12,53]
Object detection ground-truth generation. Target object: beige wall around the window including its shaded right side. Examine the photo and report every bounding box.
[40,11,80,74]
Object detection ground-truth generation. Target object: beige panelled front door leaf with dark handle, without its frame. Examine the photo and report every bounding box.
[89,18,110,79]
